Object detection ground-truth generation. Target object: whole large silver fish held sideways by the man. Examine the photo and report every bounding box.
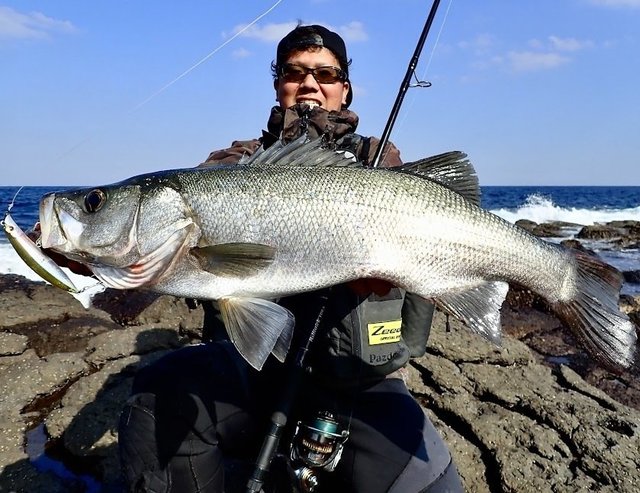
[40,140,636,368]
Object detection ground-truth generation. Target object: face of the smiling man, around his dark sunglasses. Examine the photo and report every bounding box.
[274,47,349,111]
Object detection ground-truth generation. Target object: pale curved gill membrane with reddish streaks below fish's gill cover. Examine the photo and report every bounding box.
[89,221,194,289]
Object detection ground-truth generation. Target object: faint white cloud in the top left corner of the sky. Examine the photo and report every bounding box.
[0,6,76,39]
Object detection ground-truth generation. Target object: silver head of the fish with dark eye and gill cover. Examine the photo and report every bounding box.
[40,180,195,289]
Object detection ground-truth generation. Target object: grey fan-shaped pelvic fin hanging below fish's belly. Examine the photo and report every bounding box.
[218,298,295,370]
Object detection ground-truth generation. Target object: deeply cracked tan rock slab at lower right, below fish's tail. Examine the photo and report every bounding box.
[408,314,640,492]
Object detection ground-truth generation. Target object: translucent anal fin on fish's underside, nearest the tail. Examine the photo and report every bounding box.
[436,281,509,344]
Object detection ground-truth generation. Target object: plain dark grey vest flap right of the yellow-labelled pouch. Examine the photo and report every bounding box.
[400,293,435,358]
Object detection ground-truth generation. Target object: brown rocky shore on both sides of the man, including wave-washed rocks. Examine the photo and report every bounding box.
[0,221,640,493]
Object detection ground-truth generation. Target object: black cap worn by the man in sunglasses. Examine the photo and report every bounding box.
[276,24,353,107]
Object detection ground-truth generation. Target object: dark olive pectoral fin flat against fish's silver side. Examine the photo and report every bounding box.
[191,243,276,277]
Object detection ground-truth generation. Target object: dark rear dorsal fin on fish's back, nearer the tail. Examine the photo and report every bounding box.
[392,151,480,206]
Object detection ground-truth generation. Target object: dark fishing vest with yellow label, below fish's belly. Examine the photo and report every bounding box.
[280,284,433,387]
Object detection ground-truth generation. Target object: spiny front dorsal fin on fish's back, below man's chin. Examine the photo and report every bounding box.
[241,135,362,168]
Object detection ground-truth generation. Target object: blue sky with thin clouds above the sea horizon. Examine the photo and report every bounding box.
[0,0,640,185]
